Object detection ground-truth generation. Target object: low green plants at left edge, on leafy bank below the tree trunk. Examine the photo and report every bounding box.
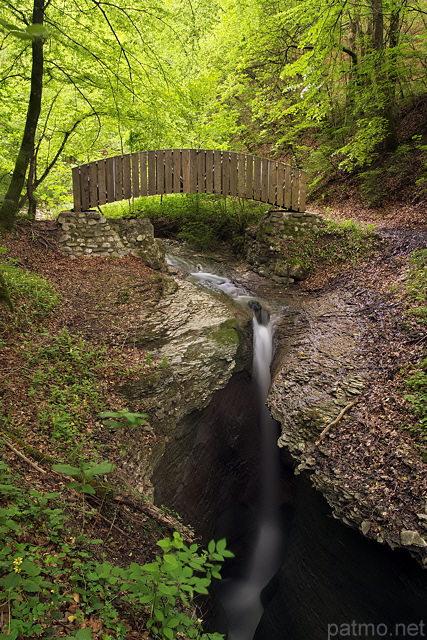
[0,258,60,331]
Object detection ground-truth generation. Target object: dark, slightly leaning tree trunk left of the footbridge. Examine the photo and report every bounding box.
[0,0,45,230]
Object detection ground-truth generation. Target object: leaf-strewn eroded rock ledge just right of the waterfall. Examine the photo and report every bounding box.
[268,290,427,566]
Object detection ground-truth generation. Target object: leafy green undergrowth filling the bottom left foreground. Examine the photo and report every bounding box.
[0,461,227,640]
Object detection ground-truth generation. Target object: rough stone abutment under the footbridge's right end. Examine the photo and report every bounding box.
[245,211,324,284]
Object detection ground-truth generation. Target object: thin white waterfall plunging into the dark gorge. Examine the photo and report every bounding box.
[221,302,282,640]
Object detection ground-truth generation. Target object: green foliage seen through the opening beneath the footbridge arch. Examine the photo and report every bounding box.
[102,194,269,252]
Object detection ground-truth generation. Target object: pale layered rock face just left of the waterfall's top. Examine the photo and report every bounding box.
[121,280,252,491]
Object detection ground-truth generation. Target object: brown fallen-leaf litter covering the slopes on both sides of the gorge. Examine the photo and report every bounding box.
[0,203,427,640]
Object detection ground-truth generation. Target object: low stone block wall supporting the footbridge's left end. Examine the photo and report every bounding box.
[57,211,166,271]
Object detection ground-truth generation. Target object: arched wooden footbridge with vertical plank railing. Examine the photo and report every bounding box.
[73,149,306,211]
